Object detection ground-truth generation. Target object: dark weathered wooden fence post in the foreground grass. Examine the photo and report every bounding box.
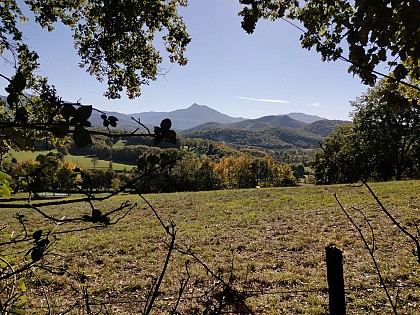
[325,246,346,315]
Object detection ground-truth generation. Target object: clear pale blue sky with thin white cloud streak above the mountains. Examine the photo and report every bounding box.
[0,0,366,119]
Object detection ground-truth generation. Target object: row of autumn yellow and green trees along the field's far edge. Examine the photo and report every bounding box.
[3,148,302,193]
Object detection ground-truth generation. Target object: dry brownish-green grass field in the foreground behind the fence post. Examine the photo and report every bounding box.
[0,181,420,314]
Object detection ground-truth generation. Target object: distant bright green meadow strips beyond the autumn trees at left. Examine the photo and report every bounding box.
[9,150,133,171]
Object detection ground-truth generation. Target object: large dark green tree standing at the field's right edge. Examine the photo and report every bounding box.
[313,79,420,184]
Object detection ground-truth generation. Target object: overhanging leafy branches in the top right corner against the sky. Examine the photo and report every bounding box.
[240,0,420,97]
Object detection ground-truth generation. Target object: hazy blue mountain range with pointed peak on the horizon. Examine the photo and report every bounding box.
[91,104,345,149]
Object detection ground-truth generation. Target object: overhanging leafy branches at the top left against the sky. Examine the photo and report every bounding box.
[0,0,190,98]
